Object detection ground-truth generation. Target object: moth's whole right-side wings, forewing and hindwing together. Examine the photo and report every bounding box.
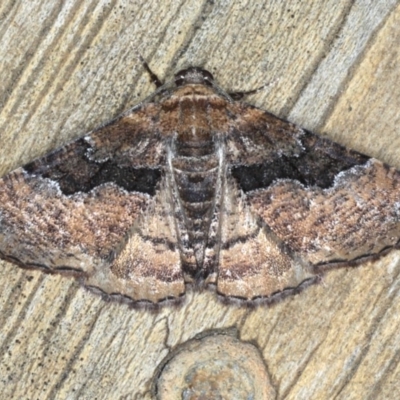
[217,103,400,299]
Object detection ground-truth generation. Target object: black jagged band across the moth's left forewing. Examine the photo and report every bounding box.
[24,139,161,196]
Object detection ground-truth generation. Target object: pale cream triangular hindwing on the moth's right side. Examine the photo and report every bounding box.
[217,178,314,300]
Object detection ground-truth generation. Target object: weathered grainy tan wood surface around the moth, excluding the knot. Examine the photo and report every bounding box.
[0,0,400,400]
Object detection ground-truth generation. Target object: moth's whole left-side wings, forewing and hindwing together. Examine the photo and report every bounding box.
[0,104,184,303]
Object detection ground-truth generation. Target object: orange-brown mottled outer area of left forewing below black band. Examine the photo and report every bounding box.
[0,168,148,275]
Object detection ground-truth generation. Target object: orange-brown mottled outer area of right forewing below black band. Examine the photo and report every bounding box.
[248,159,400,264]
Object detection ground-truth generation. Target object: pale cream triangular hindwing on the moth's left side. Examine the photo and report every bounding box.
[85,177,185,303]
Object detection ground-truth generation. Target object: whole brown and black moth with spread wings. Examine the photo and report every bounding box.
[0,64,400,306]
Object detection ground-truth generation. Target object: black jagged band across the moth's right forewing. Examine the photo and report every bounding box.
[231,131,370,192]
